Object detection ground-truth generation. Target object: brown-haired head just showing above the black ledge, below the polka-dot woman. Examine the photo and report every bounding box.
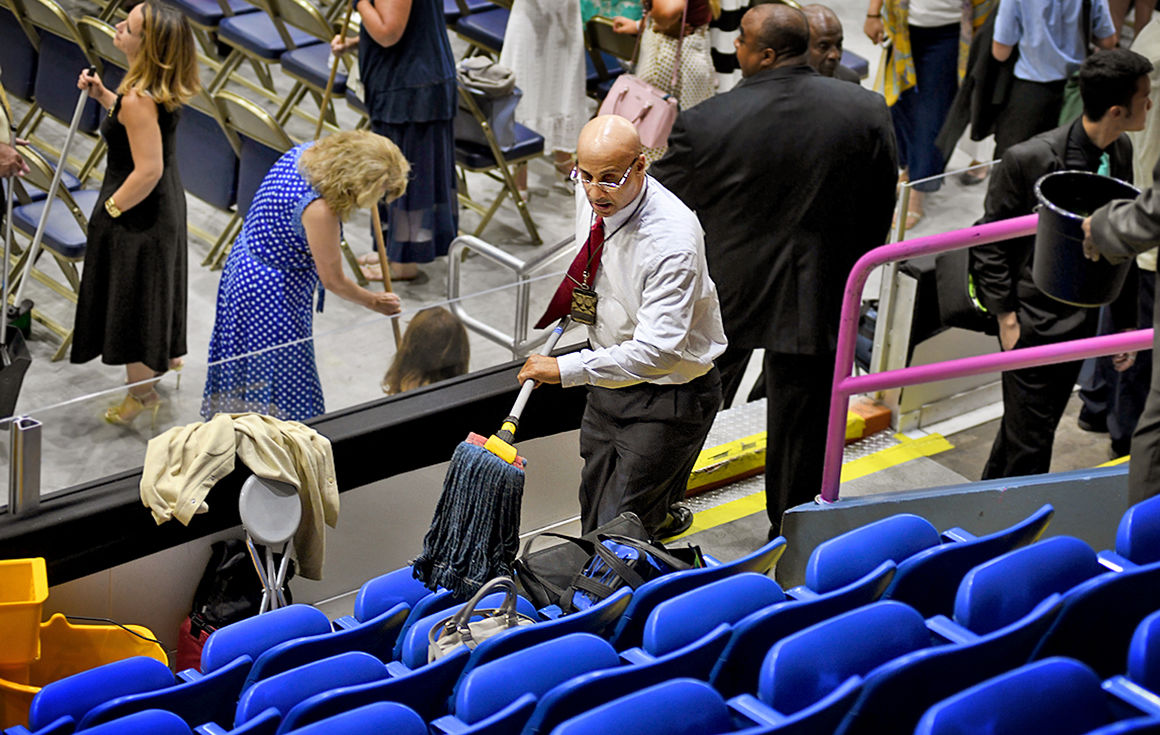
[382,306,471,395]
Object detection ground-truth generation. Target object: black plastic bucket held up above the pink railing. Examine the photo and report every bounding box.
[1031,170,1140,306]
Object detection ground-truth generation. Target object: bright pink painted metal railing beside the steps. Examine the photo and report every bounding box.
[821,208,1152,503]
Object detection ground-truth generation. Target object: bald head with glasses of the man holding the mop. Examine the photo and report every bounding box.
[577,115,645,217]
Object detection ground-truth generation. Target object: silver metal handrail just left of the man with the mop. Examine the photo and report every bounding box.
[447,235,575,359]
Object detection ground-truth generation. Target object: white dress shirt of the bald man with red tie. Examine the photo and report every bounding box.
[558,176,726,388]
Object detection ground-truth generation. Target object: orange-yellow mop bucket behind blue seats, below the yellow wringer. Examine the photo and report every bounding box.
[0,613,169,728]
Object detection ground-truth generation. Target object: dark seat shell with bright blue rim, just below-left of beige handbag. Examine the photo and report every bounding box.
[272,648,471,735]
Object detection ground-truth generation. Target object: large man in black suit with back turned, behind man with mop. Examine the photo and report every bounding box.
[650,5,898,533]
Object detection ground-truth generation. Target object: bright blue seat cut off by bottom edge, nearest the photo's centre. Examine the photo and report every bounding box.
[552,678,734,735]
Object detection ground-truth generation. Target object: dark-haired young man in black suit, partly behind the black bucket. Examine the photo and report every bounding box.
[971,49,1152,480]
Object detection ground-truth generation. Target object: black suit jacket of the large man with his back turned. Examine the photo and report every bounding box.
[648,64,898,355]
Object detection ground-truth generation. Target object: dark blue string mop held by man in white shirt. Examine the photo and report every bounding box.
[412,316,568,598]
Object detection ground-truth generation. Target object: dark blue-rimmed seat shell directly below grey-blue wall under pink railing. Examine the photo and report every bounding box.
[883,504,1054,618]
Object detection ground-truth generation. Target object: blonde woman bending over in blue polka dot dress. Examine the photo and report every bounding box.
[202,131,409,421]
